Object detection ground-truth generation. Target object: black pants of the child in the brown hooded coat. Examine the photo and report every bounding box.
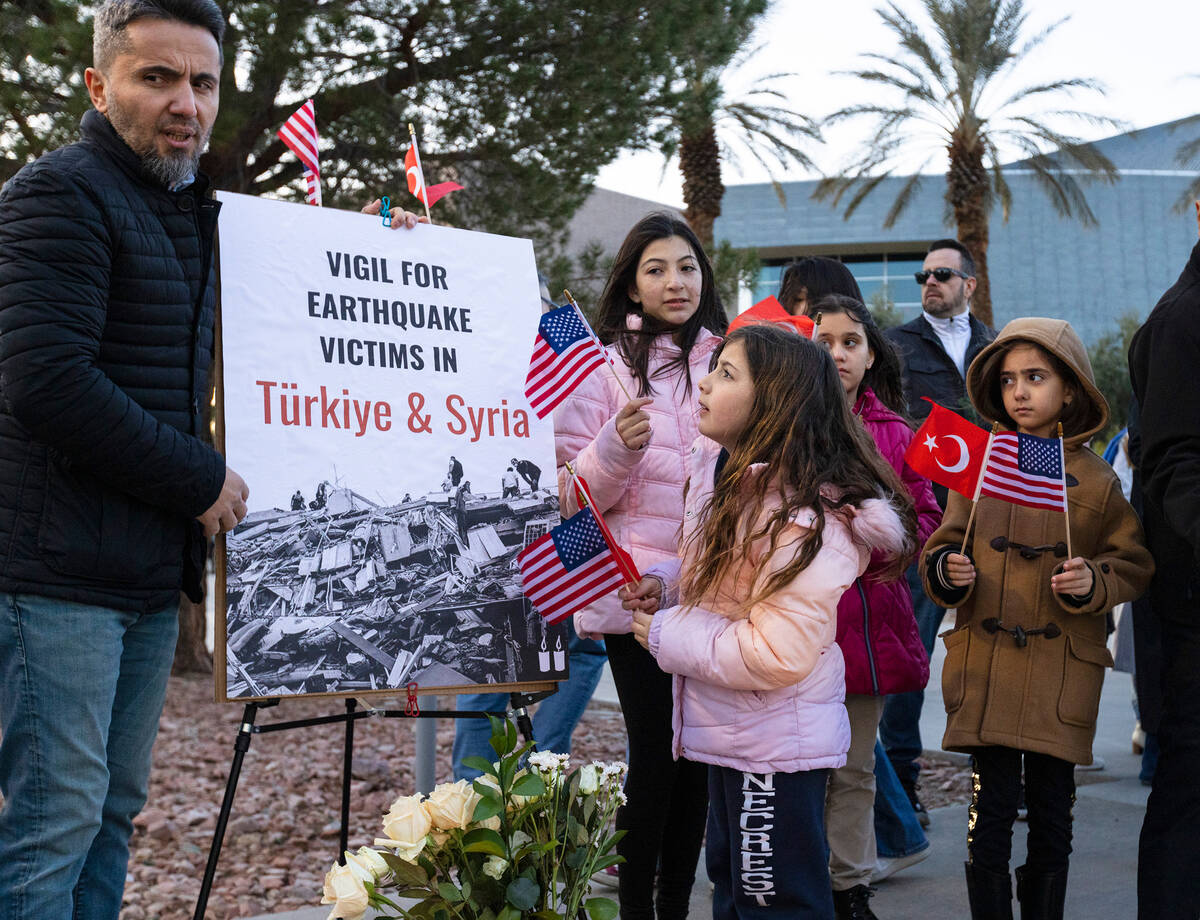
[967,747,1075,874]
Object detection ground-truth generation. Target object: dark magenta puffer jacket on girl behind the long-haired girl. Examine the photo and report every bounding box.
[838,387,942,696]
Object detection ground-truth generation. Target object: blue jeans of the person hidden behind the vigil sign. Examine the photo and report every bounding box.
[452,619,605,780]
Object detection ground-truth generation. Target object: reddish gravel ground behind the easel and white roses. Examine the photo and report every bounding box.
[121,677,625,920]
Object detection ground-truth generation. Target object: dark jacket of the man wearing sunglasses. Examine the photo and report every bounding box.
[883,313,996,422]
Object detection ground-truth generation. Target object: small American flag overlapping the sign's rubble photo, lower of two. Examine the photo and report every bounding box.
[517,507,626,623]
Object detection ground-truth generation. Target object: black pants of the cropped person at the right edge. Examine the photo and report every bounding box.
[1138,609,1200,920]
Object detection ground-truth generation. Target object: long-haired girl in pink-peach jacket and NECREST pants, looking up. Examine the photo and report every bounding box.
[622,325,916,920]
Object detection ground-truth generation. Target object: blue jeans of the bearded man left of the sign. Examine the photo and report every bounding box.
[0,594,179,920]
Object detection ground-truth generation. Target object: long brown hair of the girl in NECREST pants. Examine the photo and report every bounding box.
[680,324,917,606]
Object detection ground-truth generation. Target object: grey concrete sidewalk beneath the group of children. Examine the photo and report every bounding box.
[241,623,1150,920]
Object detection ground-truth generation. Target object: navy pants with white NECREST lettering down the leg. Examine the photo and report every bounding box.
[704,766,834,920]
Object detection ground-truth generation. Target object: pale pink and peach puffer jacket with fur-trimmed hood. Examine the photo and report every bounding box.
[649,438,904,772]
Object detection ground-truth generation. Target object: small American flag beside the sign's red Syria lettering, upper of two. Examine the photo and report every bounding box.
[526,303,607,419]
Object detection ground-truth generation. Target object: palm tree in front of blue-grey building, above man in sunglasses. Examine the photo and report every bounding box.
[815,0,1121,324]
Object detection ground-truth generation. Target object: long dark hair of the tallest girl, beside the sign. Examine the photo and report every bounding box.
[595,211,730,396]
